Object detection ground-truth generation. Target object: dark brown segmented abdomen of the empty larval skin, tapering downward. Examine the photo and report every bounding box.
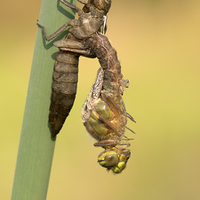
[49,51,79,137]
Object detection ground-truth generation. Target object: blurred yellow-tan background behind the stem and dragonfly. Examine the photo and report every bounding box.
[0,0,200,200]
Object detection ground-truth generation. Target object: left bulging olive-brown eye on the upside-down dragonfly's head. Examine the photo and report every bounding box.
[98,151,119,168]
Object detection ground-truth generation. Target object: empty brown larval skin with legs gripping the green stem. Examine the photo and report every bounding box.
[37,0,111,137]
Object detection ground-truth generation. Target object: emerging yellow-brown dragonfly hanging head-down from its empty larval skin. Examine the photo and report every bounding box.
[81,33,135,174]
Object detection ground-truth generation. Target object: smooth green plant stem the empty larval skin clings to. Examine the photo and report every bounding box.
[11,0,77,200]
